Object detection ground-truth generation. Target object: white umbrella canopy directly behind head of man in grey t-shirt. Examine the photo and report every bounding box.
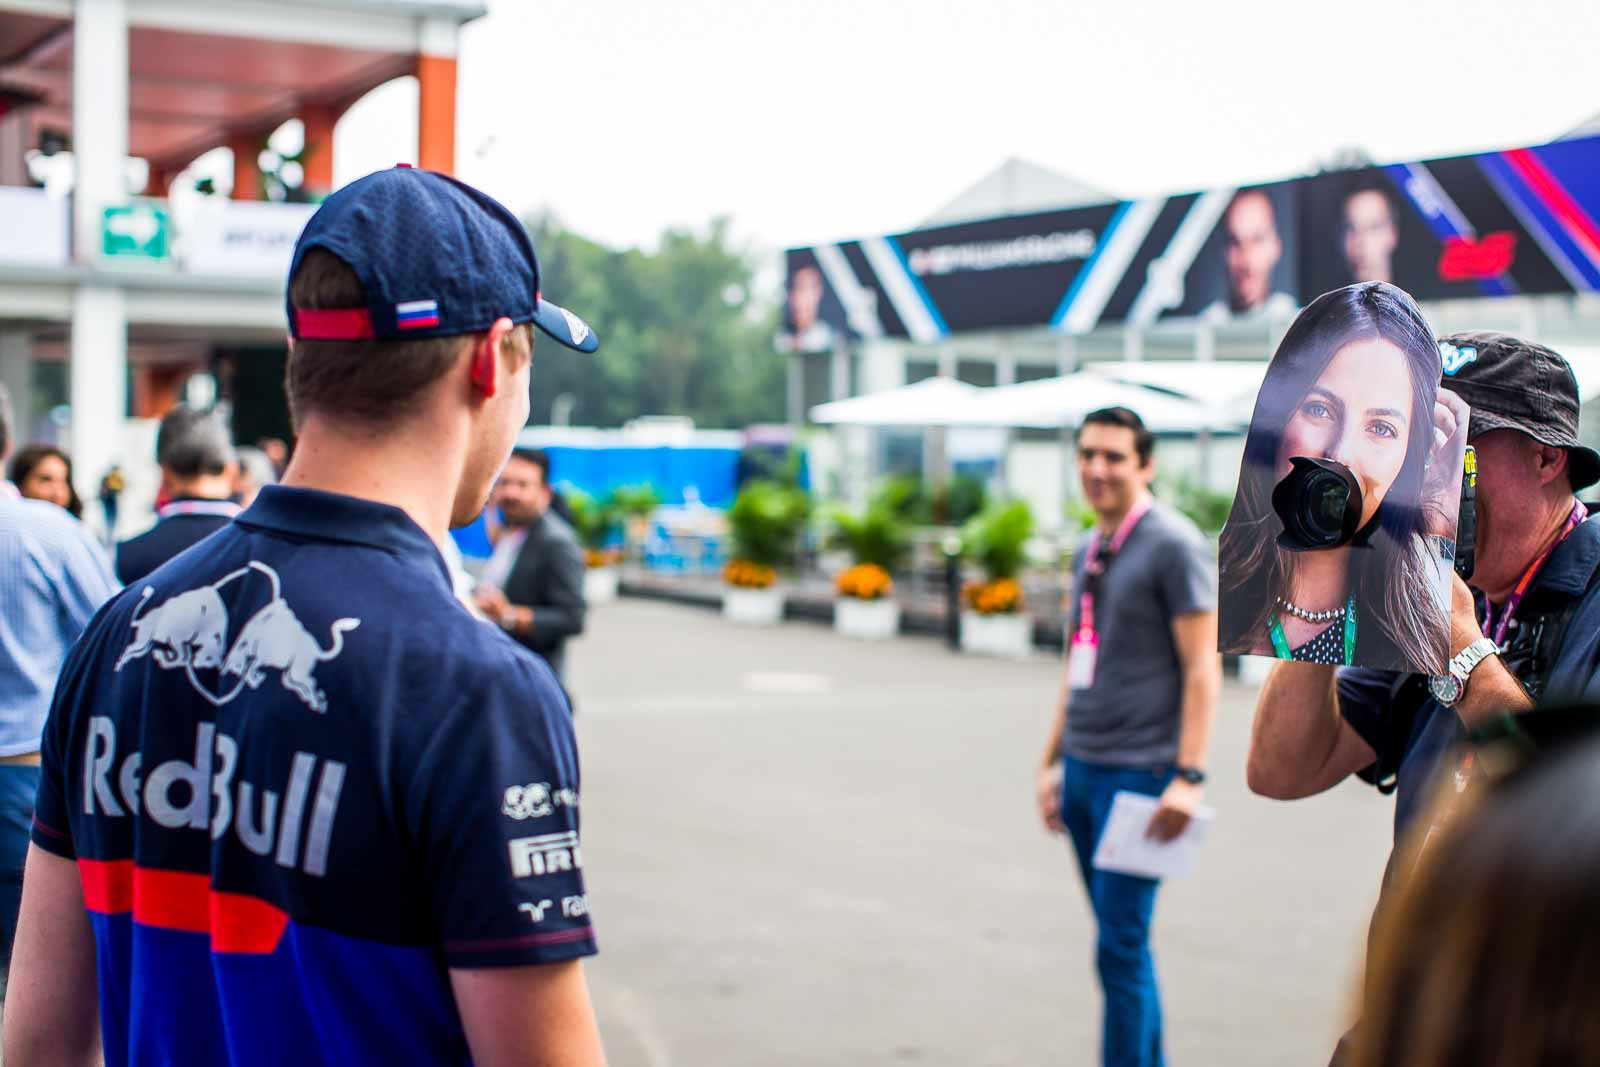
[962,371,1248,434]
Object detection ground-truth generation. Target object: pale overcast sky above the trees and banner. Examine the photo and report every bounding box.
[338,0,1600,251]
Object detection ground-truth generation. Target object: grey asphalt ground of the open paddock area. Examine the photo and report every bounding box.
[570,600,1392,1067]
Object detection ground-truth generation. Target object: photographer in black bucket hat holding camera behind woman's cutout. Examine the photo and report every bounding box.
[1246,333,1600,838]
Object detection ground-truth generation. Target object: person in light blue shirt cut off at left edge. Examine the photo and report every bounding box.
[0,386,117,991]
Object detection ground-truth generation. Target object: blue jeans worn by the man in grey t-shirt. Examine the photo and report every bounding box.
[1061,755,1173,1067]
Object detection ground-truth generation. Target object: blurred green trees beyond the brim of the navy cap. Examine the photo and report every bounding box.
[528,218,786,429]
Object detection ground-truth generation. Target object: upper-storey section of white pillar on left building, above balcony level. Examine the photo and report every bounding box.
[72,0,128,255]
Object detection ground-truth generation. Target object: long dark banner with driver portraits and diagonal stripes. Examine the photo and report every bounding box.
[781,138,1600,340]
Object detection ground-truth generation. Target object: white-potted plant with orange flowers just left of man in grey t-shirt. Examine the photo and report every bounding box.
[962,501,1034,657]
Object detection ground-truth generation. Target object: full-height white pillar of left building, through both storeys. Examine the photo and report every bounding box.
[69,0,128,499]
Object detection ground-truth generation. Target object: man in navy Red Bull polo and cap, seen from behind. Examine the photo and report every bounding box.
[5,168,603,1067]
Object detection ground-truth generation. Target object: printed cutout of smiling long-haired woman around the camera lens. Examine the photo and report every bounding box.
[1218,282,1467,673]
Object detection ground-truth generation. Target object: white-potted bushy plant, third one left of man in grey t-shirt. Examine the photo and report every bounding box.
[722,480,811,625]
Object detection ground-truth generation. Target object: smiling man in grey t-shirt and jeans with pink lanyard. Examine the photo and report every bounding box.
[1035,408,1222,1067]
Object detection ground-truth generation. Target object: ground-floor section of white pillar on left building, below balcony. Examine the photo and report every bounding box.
[67,285,128,499]
